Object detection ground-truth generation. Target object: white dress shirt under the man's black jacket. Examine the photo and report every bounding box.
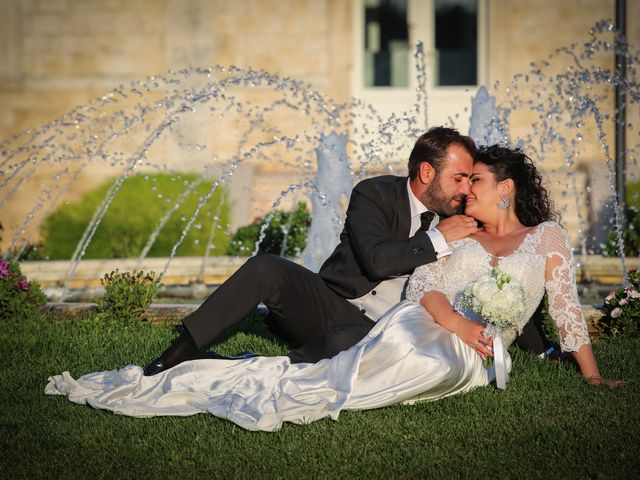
[348,179,451,322]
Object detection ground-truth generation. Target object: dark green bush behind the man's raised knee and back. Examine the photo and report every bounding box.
[227,202,311,257]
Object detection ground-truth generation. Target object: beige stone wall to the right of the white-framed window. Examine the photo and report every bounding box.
[488,0,640,247]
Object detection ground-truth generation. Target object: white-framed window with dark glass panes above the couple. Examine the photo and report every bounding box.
[351,0,489,135]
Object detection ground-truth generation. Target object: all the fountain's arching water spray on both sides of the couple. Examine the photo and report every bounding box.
[0,22,640,304]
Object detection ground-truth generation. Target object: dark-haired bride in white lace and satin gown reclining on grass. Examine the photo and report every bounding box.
[45,146,623,431]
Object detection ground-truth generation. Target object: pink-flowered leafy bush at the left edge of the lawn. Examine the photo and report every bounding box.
[0,260,47,320]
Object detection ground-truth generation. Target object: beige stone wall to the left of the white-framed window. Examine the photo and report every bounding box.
[0,0,351,247]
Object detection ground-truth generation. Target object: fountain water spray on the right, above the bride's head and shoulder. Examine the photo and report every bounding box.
[464,21,640,288]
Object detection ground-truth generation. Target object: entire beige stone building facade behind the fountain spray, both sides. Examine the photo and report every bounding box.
[0,0,640,255]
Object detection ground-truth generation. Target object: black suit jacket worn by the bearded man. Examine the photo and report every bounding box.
[319,175,437,298]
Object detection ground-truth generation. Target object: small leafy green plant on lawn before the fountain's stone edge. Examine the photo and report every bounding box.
[97,270,159,322]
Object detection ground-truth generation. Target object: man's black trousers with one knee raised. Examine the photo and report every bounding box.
[182,254,374,362]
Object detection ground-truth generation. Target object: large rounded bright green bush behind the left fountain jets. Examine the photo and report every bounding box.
[42,173,229,260]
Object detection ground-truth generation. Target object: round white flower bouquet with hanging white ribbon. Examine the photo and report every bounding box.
[462,267,524,390]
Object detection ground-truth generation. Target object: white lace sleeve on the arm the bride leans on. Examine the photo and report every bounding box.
[543,223,590,352]
